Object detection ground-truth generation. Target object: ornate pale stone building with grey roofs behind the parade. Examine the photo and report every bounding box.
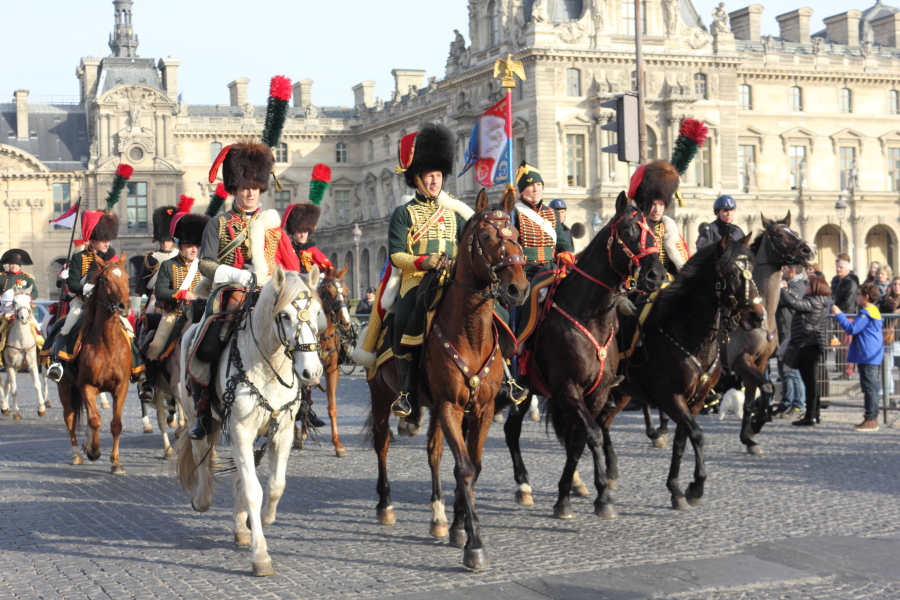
[0,0,900,298]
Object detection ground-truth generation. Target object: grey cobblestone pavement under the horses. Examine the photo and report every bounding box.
[0,378,900,600]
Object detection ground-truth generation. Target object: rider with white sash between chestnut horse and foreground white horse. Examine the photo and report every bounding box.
[141,196,209,398]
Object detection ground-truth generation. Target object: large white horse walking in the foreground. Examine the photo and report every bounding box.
[175,267,323,576]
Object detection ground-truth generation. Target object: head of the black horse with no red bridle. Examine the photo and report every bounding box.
[715,235,766,331]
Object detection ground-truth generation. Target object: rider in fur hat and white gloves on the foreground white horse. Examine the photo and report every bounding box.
[188,140,300,440]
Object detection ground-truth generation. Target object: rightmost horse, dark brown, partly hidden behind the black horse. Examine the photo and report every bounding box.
[644,211,815,455]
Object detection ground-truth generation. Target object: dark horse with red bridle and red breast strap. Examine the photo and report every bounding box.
[504,193,665,519]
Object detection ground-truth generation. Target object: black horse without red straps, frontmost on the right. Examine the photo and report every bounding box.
[596,236,765,510]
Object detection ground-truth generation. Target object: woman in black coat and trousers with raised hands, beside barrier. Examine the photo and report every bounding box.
[781,276,831,427]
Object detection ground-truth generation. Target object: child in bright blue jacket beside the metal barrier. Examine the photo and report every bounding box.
[831,283,884,431]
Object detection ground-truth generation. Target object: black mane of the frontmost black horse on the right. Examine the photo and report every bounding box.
[650,240,756,323]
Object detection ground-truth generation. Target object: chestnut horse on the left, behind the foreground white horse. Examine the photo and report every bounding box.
[57,252,131,475]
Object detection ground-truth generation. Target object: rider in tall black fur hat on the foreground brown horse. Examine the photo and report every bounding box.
[386,123,472,416]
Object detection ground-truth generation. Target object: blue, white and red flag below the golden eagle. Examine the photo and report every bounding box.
[457,94,512,187]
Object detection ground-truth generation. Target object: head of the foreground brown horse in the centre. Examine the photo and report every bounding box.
[463,188,529,306]
